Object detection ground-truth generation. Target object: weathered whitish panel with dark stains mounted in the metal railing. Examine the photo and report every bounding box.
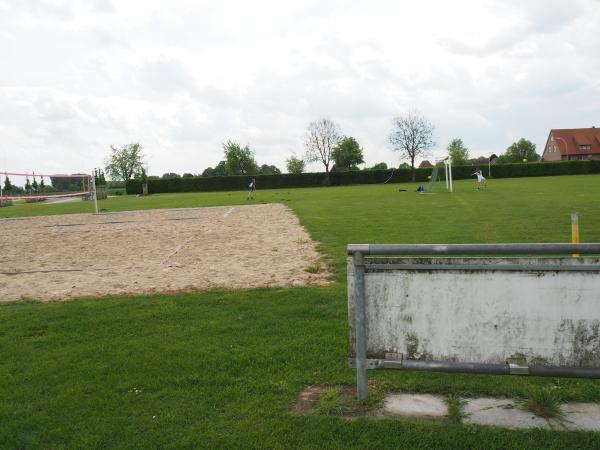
[348,258,600,367]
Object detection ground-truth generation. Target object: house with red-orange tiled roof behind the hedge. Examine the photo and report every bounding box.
[542,127,600,161]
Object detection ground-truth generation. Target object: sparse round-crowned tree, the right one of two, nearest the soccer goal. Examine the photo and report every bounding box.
[389,110,435,181]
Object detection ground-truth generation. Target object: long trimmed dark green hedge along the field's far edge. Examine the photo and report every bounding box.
[126,161,600,194]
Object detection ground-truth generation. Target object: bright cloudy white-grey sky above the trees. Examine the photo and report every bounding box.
[0,0,600,175]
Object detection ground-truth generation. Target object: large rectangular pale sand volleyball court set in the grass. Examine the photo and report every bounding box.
[0,204,329,302]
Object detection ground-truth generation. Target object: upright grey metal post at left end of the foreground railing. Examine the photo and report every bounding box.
[353,252,368,400]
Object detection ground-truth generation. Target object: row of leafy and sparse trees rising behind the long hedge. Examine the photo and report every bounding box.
[103,110,541,181]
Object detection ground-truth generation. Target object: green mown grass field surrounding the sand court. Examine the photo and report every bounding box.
[0,175,600,448]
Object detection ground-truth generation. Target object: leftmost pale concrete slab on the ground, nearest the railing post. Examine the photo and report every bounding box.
[383,394,448,420]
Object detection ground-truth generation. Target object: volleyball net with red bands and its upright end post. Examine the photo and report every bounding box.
[0,172,98,214]
